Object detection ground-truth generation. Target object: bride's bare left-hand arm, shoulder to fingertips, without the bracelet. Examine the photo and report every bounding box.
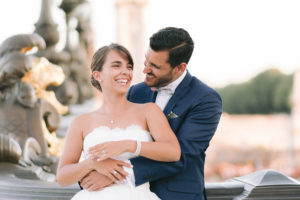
[56,117,130,186]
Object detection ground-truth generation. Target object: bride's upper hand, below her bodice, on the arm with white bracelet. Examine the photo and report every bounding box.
[88,140,136,161]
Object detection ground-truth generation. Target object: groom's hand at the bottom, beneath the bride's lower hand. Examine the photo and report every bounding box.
[80,170,114,191]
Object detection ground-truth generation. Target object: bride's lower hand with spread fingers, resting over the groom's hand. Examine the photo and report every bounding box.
[93,158,132,183]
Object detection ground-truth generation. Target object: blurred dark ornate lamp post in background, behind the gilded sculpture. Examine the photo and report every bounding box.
[35,0,93,105]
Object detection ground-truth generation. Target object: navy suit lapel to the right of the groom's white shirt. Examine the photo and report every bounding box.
[164,72,192,116]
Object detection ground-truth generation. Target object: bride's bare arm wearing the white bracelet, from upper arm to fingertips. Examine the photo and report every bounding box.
[89,103,181,162]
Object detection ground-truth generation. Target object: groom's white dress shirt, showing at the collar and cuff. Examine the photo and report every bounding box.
[124,70,187,187]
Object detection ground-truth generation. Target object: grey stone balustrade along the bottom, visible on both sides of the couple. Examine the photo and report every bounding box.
[0,163,300,200]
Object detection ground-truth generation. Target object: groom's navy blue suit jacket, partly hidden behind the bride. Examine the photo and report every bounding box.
[127,72,222,200]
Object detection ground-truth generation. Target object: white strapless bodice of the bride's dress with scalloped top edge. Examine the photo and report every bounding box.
[83,125,153,160]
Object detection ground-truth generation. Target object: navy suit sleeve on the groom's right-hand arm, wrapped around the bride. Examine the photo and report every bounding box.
[130,92,222,186]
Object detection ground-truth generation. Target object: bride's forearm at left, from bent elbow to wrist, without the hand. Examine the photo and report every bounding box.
[56,159,93,186]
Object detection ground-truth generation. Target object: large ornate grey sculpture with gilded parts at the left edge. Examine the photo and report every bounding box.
[0,34,68,181]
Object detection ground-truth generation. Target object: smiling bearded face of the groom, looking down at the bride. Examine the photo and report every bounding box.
[143,48,176,87]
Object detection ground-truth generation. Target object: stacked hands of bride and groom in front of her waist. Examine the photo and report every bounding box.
[80,141,135,191]
